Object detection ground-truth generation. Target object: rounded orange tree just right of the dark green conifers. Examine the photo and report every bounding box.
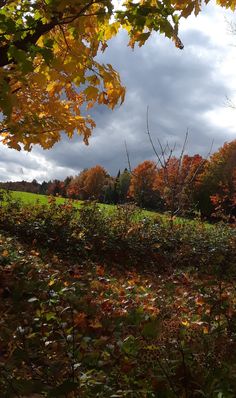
[129,160,160,208]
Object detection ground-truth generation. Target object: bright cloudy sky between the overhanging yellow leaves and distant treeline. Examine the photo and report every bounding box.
[0,4,236,181]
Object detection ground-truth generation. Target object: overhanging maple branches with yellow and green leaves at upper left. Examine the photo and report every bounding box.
[0,0,236,150]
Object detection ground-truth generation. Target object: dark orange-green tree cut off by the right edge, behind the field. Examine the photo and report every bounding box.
[197,140,236,220]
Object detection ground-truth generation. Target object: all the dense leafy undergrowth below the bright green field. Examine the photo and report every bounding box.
[0,192,236,398]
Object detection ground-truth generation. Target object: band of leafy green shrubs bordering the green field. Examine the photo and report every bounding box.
[0,195,236,275]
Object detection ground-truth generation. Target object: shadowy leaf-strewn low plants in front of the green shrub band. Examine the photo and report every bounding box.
[0,235,236,398]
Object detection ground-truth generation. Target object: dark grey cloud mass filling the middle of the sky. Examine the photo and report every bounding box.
[33,30,232,174]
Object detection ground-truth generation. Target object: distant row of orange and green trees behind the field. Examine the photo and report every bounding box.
[0,140,236,222]
